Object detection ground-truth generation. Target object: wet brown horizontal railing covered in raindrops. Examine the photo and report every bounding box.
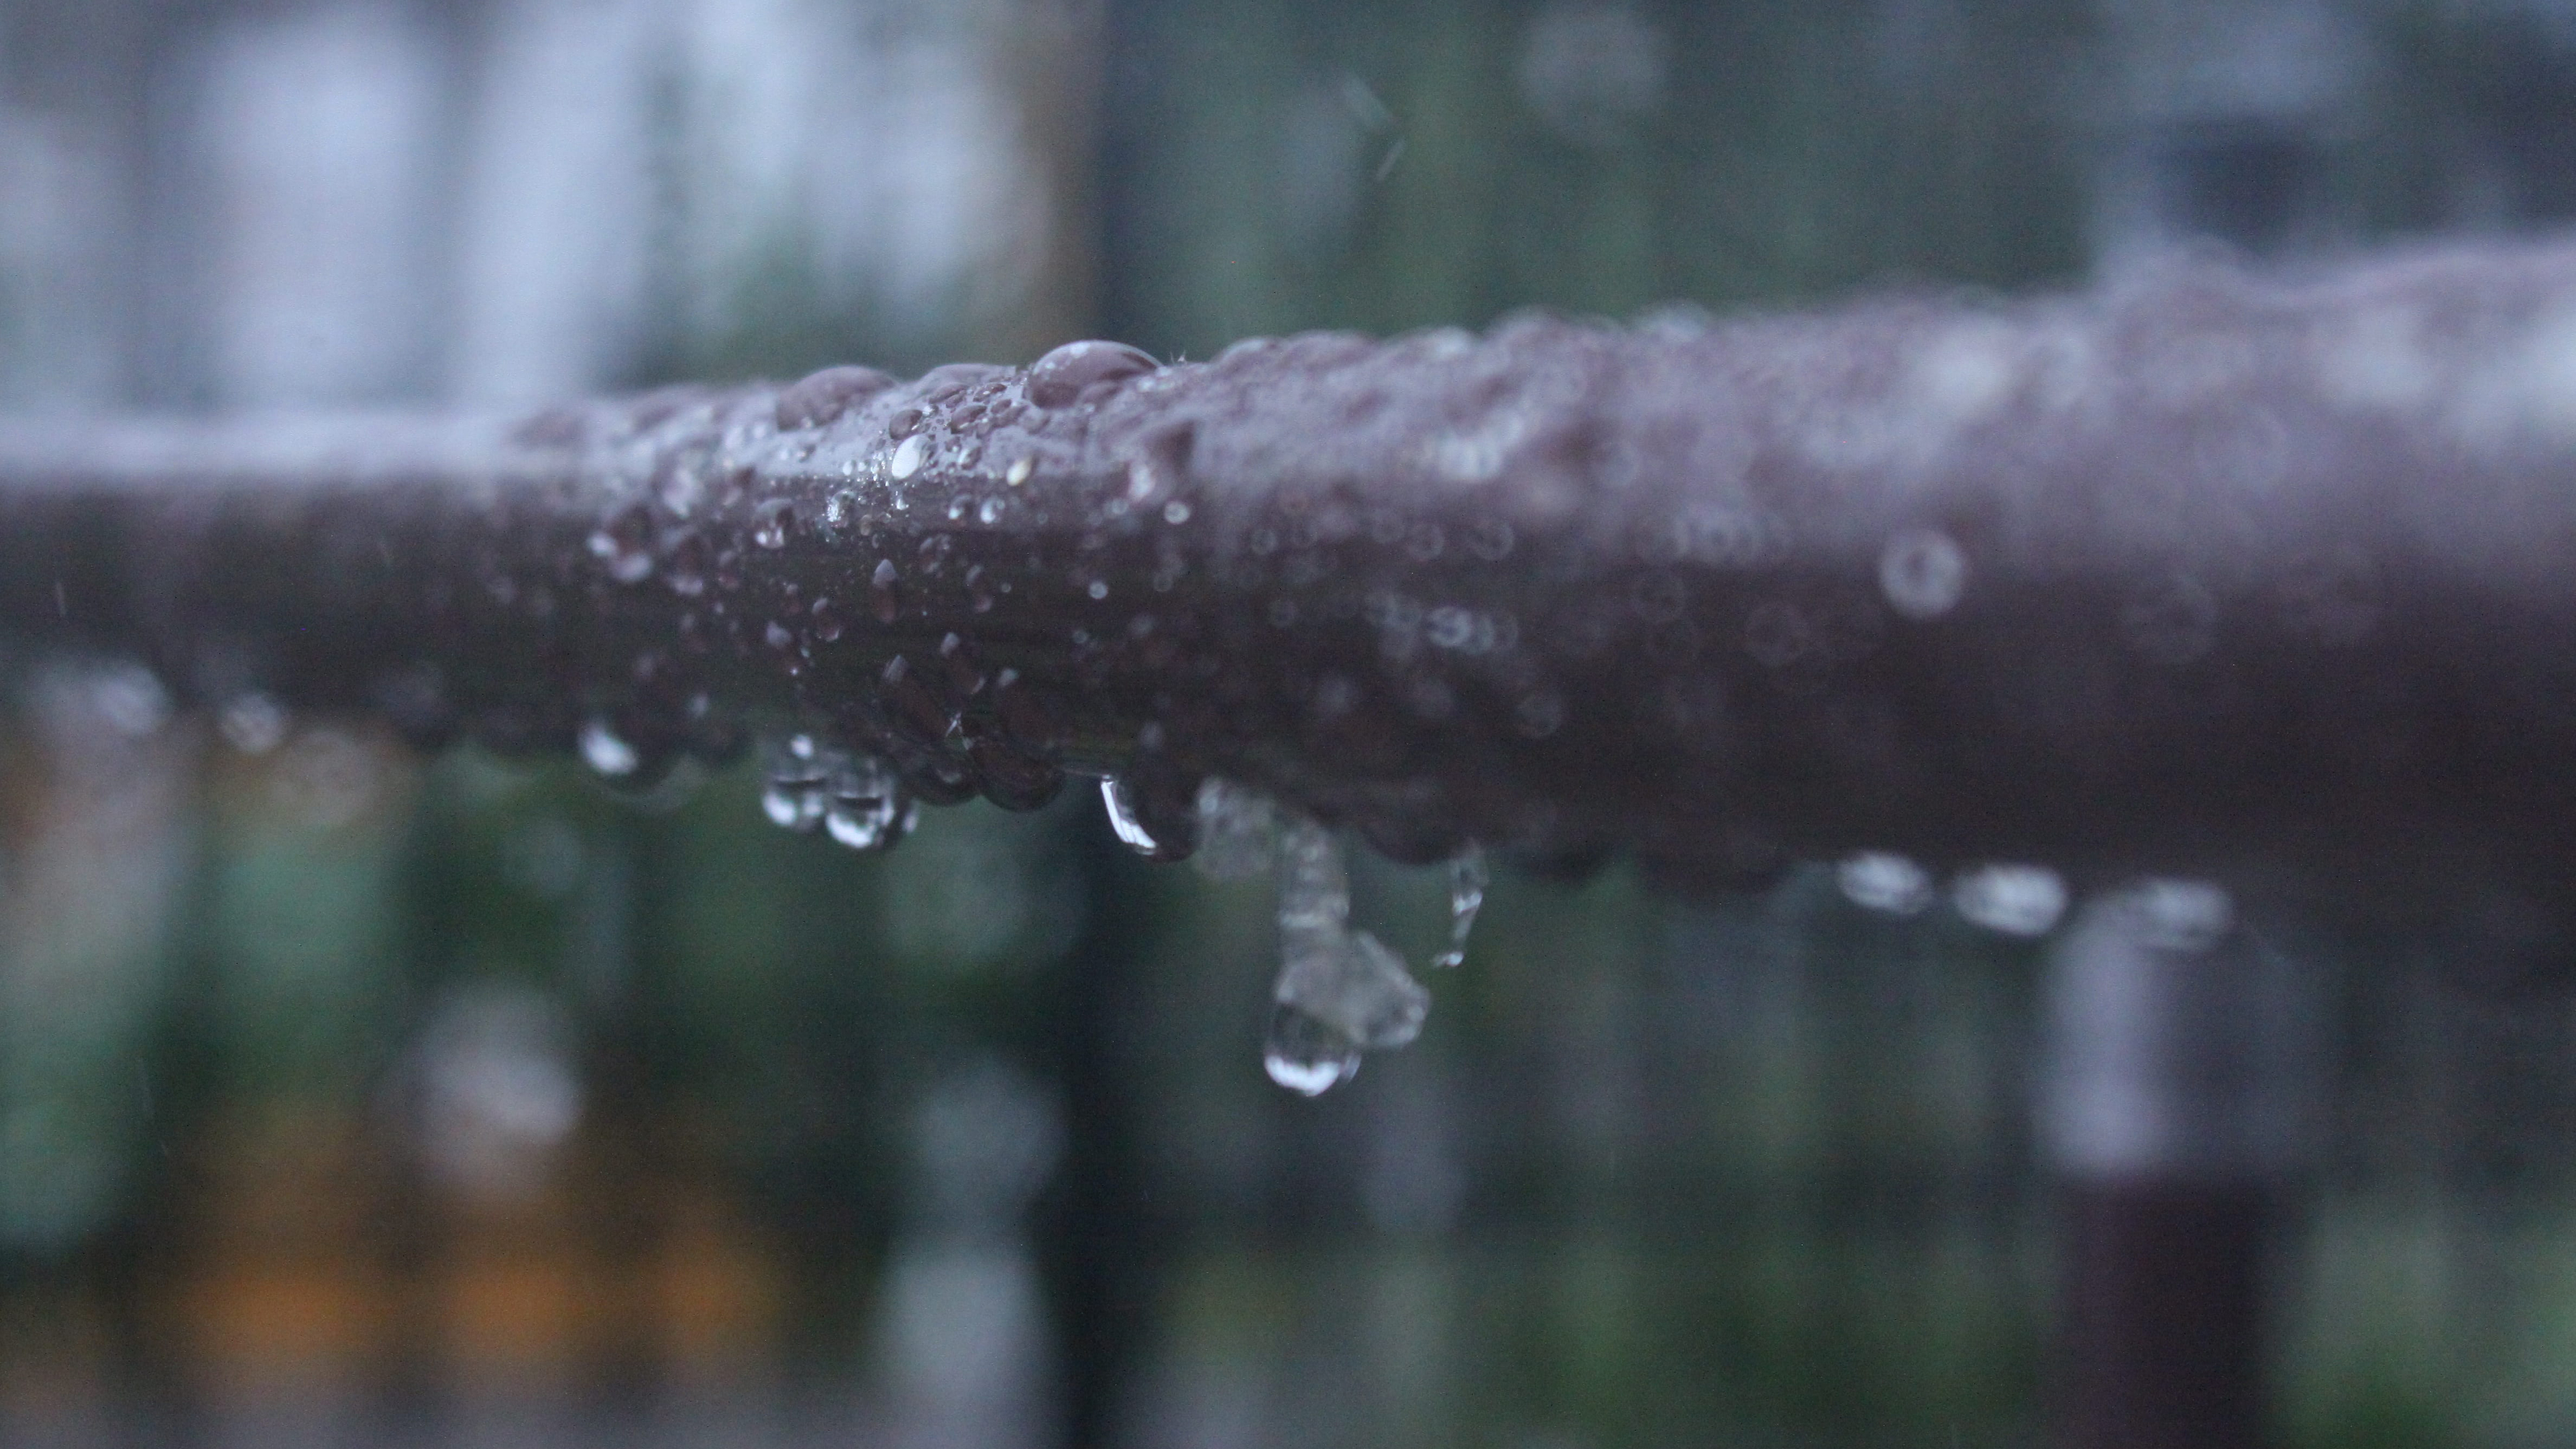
[0,245,2576,933]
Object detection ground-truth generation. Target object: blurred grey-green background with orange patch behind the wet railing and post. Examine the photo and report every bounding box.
[0,0,2576,1449]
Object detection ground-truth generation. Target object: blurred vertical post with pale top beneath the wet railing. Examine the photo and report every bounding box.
[2040,881,2318,1449]
